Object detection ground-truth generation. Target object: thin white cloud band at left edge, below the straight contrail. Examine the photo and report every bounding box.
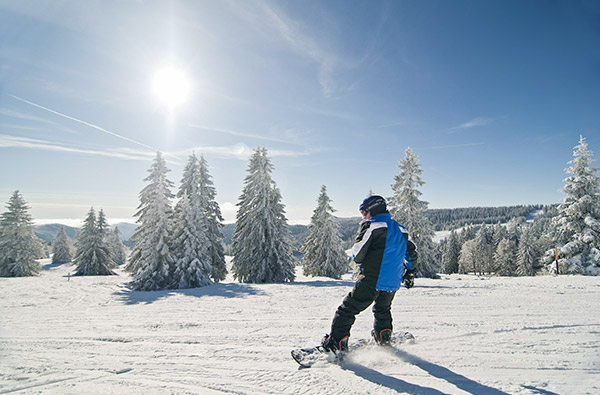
[0,134,154,161]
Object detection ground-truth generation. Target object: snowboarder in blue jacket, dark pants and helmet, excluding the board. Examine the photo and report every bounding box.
[321,195,417,354]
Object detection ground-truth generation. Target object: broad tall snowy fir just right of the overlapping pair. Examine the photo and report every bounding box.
[232,147,295,283]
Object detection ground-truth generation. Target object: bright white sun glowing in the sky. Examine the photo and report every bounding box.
[152,65,190,110]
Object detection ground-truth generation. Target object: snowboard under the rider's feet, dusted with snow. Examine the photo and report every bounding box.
[291,332,415,368]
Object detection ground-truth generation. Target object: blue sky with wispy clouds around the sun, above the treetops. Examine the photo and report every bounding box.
[0,0,600,223]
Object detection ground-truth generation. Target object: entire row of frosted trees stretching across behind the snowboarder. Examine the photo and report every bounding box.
[0,137,600,284]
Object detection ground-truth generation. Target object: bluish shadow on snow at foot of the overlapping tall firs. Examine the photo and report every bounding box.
[115,283,263,304]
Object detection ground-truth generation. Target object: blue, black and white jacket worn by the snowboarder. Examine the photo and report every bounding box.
[352,212,418,292]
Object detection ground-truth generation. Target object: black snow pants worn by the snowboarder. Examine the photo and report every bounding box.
[330,277,396,341]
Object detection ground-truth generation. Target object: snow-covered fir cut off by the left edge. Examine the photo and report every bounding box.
[0,191,41,277]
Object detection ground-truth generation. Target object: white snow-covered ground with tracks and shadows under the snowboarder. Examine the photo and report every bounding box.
[0,261,600,395]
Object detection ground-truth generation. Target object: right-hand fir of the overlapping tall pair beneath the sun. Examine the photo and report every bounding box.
[173,155,212,288]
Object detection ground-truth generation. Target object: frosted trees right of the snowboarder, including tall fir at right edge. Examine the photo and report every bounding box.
[438,136,600,276]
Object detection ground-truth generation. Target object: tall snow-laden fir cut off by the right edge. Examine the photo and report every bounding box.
[548,136,600,275]
